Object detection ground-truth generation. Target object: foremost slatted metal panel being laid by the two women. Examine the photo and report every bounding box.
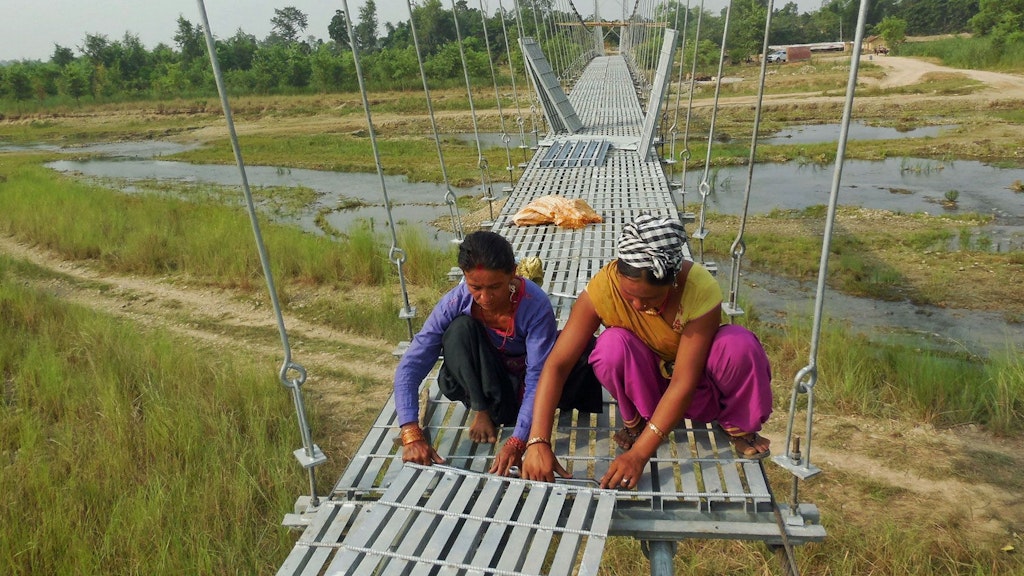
[290,464,615,576]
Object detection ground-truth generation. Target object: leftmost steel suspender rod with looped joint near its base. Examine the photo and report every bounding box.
[197,0,327,506]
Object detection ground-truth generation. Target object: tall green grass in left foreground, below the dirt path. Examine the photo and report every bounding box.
[0,258,301,574]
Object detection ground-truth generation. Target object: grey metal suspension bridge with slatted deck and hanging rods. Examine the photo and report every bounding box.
[193,0,863,576]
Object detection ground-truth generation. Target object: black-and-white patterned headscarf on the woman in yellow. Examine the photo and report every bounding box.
[618,214,686,280]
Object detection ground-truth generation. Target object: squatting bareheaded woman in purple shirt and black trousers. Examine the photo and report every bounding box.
[394,232,601,476]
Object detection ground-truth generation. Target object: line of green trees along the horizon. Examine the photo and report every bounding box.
[0,0,1024,104]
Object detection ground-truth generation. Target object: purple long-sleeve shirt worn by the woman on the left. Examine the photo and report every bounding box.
[394,280,558,440]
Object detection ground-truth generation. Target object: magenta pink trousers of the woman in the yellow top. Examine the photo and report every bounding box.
[590,324,772,433]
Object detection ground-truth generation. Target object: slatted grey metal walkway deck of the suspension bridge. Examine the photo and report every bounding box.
[280,56,824,574]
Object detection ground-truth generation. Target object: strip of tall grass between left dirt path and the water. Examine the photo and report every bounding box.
[0,157,390,289]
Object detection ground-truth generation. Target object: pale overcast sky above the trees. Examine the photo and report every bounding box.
[0,0,821,60]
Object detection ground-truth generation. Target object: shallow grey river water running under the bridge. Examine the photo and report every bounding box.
[9,132,1024,355]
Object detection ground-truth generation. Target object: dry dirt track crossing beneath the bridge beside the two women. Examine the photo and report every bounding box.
[0,231,1024,545]
